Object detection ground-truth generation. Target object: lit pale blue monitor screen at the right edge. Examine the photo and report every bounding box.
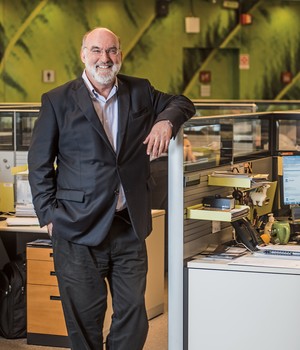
[282,155,300,205]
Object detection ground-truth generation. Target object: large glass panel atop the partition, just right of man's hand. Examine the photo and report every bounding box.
[184,113,272,172]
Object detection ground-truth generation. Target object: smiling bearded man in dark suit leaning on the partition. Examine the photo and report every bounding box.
[28,28,195,350]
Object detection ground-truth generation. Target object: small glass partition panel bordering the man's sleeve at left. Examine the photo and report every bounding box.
[16,110,38,151]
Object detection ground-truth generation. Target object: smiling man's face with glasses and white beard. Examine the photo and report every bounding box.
[81,29,122,86]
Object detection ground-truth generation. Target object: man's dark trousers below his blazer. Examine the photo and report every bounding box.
[52,211,148,350]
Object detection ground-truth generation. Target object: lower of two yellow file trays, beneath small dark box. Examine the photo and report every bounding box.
[186,204,250,222]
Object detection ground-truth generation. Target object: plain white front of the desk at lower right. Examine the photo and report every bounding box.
[187,254,300,350]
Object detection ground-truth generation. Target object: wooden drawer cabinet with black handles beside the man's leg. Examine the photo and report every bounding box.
[26,246,69,347]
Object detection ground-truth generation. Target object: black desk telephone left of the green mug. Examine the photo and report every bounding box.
[231,218,258,251]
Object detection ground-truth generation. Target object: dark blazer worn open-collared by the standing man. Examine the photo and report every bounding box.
[28,75,195,246]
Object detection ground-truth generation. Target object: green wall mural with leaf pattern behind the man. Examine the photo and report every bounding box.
[0,0,300,102]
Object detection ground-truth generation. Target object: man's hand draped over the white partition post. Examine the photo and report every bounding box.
[144,120,172,158]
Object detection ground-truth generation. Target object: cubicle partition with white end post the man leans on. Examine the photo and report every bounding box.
[168,111,300,350]
